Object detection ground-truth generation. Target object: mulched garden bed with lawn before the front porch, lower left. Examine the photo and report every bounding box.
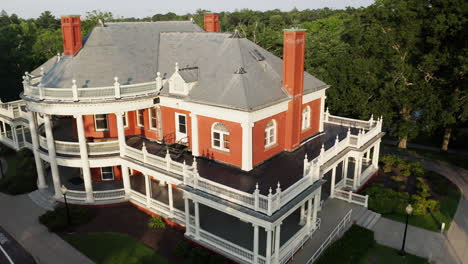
[41,204,230,264]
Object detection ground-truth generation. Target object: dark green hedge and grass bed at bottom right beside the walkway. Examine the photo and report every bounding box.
[315,225,427,264]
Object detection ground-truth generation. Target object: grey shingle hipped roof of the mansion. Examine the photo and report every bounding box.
[36,21,326,111]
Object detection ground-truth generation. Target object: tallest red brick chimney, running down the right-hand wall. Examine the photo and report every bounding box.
[283,29,306,150]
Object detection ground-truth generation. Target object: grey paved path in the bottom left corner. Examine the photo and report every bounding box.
[0,193,93,264]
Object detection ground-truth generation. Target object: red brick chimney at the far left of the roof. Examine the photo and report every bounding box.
[60,16,83,56]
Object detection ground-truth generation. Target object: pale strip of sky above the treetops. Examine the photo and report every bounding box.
[0,0,374,18]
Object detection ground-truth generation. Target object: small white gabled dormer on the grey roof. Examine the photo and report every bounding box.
[168,63,198,95]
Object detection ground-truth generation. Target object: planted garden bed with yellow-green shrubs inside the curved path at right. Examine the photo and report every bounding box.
[363,155,461,231]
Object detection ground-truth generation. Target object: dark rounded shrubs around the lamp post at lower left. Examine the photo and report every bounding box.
[39,205,94,232]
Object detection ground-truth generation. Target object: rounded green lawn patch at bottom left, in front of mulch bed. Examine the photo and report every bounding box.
[64,233,168,264]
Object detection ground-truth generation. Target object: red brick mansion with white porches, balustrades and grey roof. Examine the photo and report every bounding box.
[0,14,384,264]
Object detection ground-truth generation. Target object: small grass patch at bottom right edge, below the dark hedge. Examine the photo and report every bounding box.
[357,244,428,264]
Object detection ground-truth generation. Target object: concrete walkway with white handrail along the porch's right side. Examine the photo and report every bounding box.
[290,199,365,264]
